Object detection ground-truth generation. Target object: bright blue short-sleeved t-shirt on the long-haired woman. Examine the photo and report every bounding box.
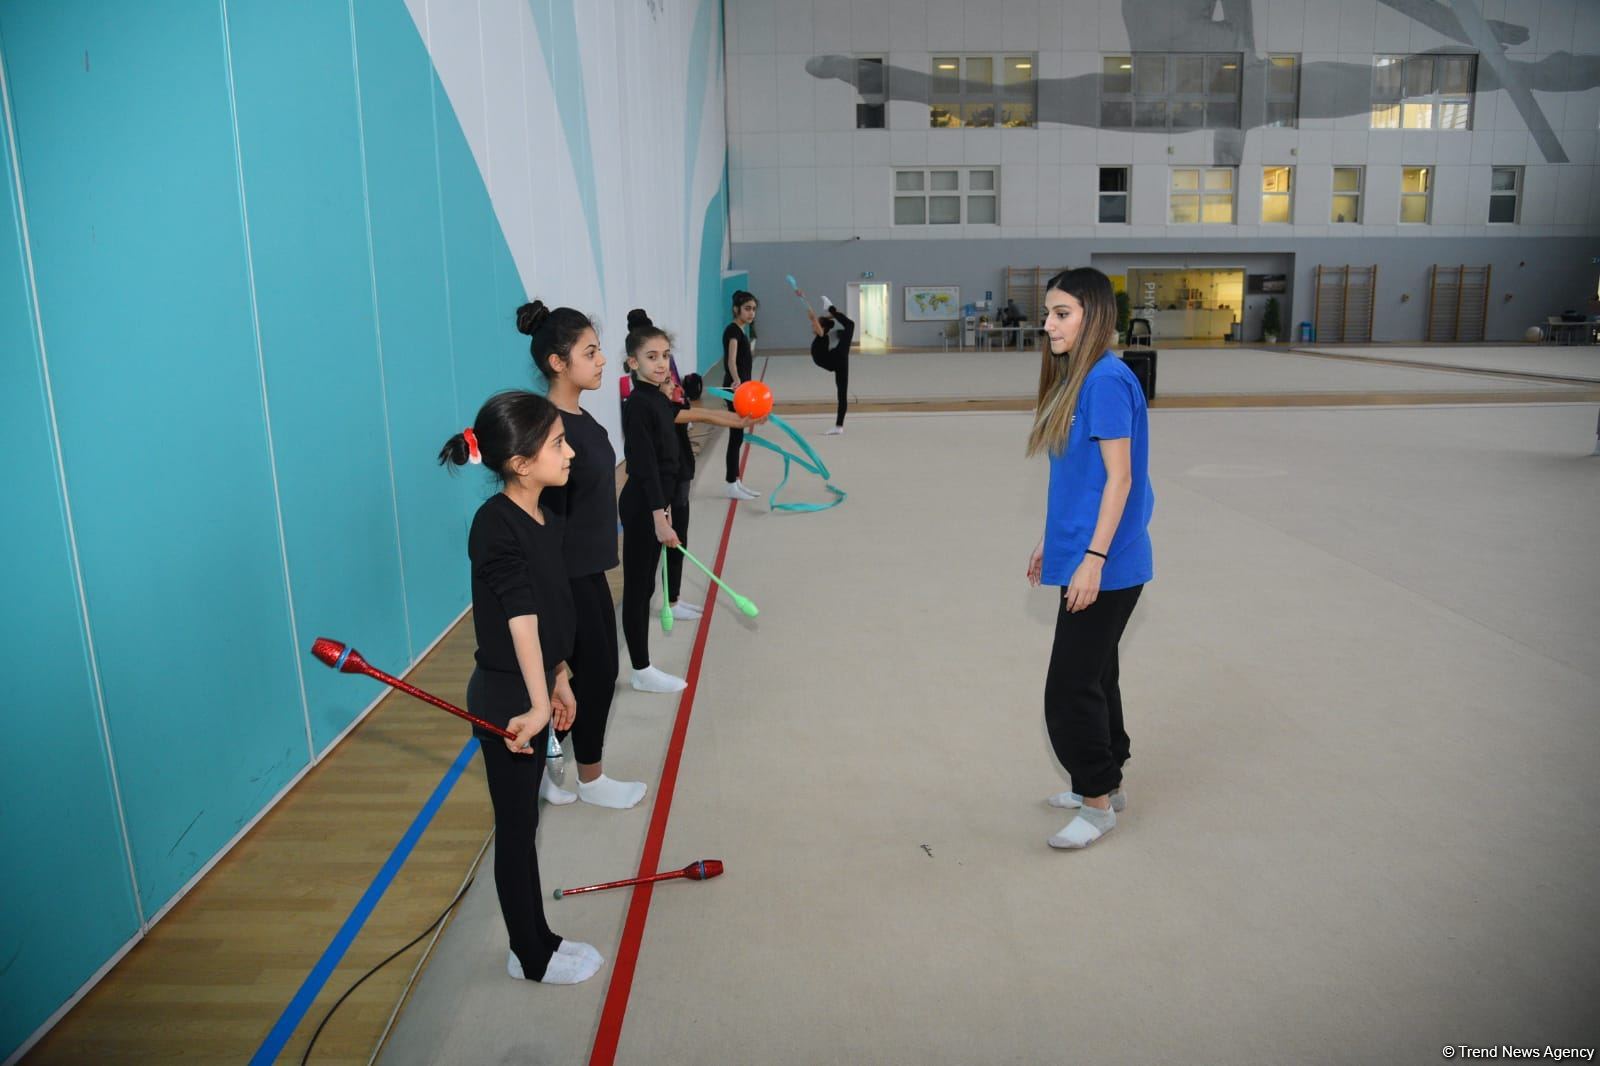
[1040,352,1155,591]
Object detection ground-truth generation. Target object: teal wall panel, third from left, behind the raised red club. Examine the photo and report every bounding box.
[227,0,406,751]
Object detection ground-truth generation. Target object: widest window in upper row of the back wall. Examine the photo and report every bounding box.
[1101,53,1240,133]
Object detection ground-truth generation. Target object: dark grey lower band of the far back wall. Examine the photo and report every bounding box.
[733,237,1600,349]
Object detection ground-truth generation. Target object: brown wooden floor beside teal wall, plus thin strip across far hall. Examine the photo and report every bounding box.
[24,371,1600,1066]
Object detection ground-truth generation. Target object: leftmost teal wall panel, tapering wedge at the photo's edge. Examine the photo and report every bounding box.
[0,20,139,1060]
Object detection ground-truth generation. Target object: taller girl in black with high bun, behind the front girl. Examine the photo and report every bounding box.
[517,299,645,810]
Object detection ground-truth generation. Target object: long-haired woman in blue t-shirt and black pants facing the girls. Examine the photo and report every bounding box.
[1027,267,1155,848]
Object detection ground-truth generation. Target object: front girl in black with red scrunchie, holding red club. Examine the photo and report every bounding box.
[438,392,605,984]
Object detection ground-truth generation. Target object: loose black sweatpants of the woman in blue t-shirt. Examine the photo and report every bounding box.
[1045,584,1144,795]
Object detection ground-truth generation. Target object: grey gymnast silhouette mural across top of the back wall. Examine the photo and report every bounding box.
[806,0,1600,166]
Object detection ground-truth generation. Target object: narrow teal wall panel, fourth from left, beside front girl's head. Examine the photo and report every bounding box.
[355,0,470,653]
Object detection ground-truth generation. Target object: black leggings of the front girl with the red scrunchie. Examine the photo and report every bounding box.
[467,669,562,981]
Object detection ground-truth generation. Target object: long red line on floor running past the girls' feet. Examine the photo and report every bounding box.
[589,367,765,1066]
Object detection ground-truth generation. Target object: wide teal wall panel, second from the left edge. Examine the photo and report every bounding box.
[3,0,309,912]
